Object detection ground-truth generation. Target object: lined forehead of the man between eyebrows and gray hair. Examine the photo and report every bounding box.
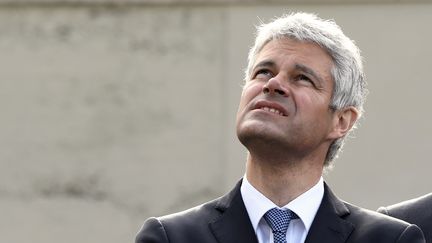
[254,38,333,76]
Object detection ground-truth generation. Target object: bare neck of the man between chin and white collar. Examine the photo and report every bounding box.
[246,154,323,207]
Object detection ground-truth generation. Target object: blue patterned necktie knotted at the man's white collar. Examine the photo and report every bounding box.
[264,208,298,243]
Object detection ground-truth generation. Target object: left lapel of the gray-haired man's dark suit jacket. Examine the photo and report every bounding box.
[210,181,258,243]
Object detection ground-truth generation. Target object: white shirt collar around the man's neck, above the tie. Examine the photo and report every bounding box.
[240,175,324,232]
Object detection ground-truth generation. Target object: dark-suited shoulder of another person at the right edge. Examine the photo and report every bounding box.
[378,193,432,243]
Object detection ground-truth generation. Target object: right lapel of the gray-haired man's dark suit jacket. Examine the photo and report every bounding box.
[305,184,354,243]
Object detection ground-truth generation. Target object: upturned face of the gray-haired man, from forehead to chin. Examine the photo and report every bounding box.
[237,38,335,159]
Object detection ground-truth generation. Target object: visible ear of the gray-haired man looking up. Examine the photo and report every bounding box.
[329,106,359,139]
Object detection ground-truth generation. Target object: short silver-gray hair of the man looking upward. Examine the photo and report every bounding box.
[245,13,367,166]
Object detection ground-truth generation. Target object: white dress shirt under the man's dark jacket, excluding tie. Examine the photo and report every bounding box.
[240,175,324,243]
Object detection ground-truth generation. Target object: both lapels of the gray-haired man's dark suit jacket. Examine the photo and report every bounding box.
[209,180,354,243]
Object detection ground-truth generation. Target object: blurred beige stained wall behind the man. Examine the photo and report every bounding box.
[0,0,432,243]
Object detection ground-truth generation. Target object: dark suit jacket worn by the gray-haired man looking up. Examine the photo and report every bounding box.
[136,179,424,243]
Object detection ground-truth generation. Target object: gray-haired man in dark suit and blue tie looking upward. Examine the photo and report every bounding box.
[136,13,424,243]
